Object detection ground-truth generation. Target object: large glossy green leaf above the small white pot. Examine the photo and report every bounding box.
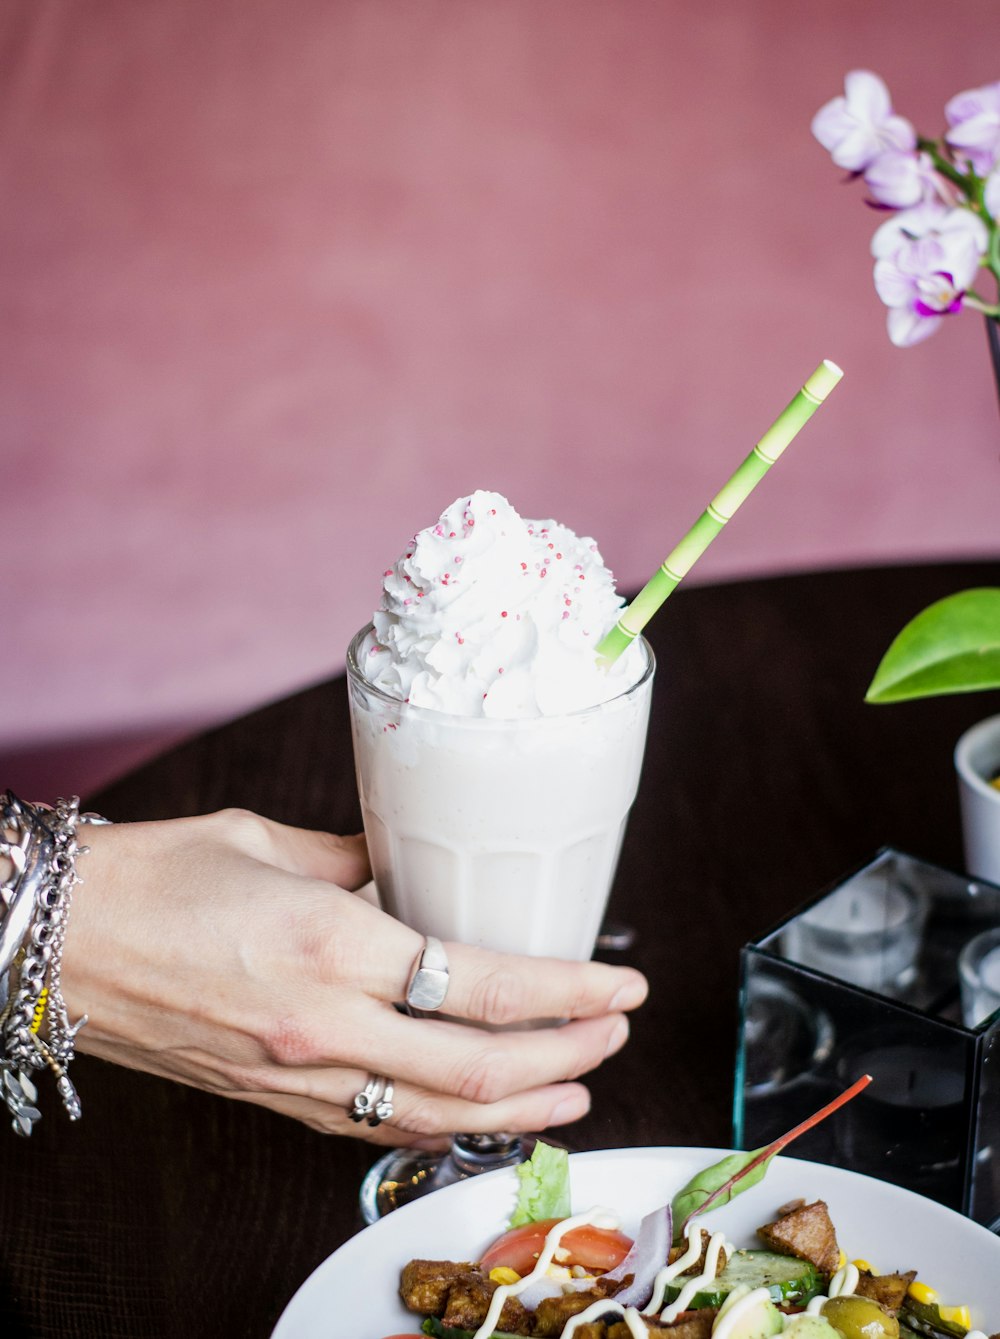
[865,586,1000,703]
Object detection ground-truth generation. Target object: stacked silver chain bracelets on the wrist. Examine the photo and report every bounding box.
[0,790,107,1135]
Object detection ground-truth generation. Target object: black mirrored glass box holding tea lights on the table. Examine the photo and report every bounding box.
[734,849,1000,1228]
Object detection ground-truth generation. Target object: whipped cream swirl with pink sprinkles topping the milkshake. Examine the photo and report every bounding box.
[360,491,645,719]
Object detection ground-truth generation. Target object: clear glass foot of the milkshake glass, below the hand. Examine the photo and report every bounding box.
[360,1134,543,1223]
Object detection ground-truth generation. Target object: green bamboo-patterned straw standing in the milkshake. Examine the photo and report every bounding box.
[597,358,843,668]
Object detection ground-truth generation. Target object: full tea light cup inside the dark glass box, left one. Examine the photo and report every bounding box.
[784,870,924,994]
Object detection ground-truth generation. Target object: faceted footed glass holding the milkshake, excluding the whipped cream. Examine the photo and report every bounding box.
[347,625,655,1216]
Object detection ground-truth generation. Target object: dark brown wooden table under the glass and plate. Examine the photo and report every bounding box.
[0,561,1000,1339]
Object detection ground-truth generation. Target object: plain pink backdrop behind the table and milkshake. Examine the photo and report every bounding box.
[0,0,1000,789]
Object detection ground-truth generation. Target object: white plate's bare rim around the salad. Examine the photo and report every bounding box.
[273,1149,1000,1339]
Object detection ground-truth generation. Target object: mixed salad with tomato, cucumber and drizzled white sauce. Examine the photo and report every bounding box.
[388,1137,985,1339]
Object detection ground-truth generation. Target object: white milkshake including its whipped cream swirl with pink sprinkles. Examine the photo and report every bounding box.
[348,493,653,960]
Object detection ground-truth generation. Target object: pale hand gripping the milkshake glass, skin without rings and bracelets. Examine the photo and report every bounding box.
[63,810,647,1145]
